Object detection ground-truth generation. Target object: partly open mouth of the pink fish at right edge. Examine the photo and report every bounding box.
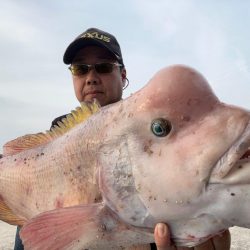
[209,123,250,184]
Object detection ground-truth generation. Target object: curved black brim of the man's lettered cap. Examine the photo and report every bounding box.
[63,38,123,64]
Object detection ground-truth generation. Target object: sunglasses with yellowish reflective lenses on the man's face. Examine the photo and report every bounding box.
[69,62,122,76]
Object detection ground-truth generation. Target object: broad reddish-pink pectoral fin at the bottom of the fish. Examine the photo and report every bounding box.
[20,203,153,250]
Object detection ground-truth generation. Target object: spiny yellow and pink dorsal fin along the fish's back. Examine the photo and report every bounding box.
[3,101,100,156]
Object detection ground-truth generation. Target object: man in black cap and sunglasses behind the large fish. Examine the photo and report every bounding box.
[15,28,229,250]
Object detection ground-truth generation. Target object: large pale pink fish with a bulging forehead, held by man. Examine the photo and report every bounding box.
[0,65,250,250]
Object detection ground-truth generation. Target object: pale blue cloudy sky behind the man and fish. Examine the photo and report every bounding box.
[0,0,250,152]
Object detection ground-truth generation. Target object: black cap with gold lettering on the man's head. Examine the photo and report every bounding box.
[63,28,124,65]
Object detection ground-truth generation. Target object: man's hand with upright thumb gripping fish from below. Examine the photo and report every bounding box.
[154,223,231,250]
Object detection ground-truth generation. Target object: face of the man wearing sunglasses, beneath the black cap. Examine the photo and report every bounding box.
[72,46,126,106]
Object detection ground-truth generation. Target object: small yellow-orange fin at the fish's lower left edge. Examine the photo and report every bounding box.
[0,199,26,226]
